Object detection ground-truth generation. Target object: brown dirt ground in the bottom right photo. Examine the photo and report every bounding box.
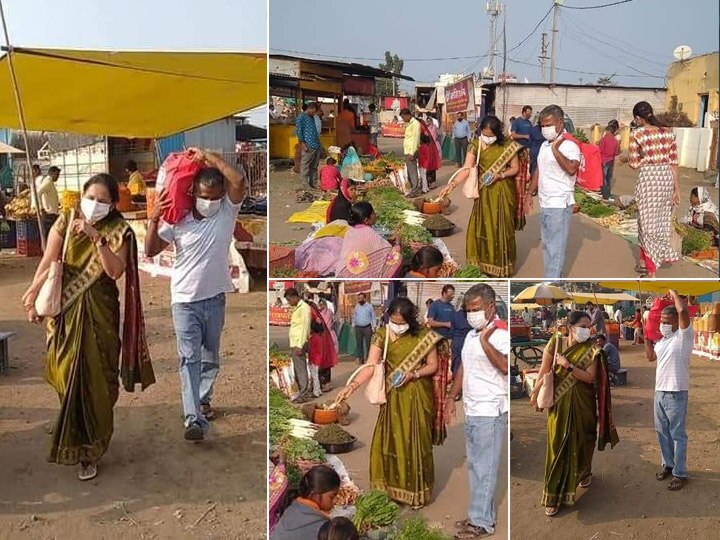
[510,341,720,540]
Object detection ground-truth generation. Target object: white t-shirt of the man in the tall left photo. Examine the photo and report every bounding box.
[158,195,240,304]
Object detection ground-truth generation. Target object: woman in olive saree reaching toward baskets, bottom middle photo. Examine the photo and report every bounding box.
[339,298,449,508]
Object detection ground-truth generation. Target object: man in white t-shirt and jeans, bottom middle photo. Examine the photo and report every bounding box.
[445,284,510,538]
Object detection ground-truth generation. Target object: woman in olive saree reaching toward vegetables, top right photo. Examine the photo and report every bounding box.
[442,116,525,277]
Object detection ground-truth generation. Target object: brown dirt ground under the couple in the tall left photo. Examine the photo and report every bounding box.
[0,255,267,540]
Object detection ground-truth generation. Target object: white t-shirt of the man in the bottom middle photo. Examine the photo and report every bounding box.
[461,322,510,417]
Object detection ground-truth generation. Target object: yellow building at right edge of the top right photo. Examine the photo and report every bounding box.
[666,52,720,127]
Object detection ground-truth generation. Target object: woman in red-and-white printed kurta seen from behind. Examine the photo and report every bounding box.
[629,101,680,278]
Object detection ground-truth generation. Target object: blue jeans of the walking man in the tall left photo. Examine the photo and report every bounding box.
[172,294,225,431]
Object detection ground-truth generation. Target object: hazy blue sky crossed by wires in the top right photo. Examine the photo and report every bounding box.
[270,0,719,86]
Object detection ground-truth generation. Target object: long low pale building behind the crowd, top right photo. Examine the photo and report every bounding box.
[481,82,665,128]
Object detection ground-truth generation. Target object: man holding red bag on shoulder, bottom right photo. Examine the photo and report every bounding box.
[645,290,695,491]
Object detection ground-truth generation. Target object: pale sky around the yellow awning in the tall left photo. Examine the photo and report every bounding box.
[3,0,267,125]
